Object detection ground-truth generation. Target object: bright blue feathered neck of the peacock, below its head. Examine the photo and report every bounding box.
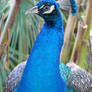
[14,11,66,92]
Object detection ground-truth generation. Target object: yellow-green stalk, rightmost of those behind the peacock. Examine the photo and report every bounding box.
[78,0,92,67]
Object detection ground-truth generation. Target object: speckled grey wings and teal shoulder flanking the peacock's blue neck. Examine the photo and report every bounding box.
[4,61,92,92]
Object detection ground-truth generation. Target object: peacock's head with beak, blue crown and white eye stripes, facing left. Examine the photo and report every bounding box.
[26,0,60,21]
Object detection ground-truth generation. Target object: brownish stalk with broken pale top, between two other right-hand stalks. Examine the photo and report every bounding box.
[70,22,87,63]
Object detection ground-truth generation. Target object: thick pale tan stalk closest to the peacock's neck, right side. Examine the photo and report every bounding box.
[60,0,80,63]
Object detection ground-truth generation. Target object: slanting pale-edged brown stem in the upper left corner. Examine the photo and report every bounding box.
[0,0,21,60]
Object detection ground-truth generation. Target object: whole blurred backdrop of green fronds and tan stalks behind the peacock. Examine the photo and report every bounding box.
[0,0,92,92]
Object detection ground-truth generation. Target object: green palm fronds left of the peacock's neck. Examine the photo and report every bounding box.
[0,0,43,92]
